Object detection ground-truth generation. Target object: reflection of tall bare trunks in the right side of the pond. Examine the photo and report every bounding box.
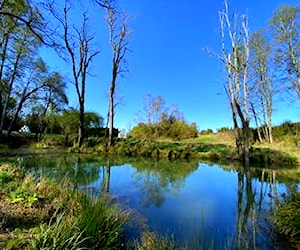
[232,169,295,249]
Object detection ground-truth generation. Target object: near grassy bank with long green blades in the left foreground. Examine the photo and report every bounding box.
[0,159,129,249]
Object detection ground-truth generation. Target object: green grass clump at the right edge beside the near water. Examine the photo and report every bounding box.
[274,192,300,241]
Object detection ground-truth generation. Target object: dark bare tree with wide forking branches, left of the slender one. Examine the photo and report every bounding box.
[48,1,100,147]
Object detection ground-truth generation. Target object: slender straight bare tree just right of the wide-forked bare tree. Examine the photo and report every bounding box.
[106,8,130,147]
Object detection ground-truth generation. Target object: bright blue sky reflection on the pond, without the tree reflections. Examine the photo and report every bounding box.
[81,164,292,248]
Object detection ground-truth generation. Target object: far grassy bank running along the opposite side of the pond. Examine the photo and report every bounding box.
[0,131,300,168]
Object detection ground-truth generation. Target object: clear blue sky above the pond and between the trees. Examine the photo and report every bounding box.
[44,0,300,130]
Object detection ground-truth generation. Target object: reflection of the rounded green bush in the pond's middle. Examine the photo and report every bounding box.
[132,160,198,207]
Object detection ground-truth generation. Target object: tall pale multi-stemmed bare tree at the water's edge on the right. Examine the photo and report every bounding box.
[219,0,250,166]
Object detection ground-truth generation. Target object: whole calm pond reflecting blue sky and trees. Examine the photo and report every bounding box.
[20,155,299,249]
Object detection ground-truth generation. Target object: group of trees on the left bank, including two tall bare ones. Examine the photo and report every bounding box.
[0,0,125,147]
